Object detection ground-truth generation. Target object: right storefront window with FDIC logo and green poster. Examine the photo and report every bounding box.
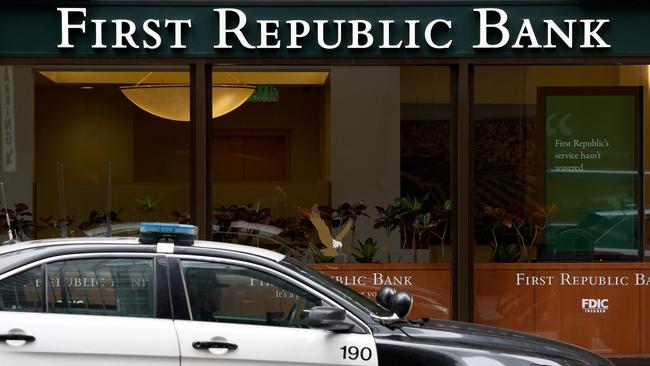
[472,65,650,354]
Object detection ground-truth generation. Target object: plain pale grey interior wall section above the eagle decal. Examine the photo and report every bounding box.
[330,66,400,258]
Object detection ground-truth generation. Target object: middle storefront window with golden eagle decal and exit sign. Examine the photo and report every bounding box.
[212,67,451,318]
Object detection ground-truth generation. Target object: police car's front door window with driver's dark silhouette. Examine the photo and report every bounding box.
[181,261,322,328]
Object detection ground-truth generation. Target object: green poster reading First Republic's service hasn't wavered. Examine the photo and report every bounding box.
[538,87,642,261]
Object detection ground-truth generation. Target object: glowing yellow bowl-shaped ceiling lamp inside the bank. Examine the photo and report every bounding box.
[120,73,255,122]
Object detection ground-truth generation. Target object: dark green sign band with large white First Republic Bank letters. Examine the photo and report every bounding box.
[22,1,636,58]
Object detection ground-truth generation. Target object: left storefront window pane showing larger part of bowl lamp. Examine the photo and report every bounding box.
[33,68,190,238]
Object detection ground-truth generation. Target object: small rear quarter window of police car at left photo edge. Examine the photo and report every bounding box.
[0,266,43,312]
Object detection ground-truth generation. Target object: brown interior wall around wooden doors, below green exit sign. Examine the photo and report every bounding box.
[212,85,329,217]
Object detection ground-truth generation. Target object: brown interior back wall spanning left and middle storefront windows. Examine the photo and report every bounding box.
[30,80,329,227]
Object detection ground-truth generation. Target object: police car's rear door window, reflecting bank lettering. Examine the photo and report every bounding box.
[47,258,155,318]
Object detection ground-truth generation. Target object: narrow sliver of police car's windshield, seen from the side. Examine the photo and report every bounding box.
[281,257,393,317]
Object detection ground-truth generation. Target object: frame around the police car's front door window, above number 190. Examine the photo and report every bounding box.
[169,254,372,334]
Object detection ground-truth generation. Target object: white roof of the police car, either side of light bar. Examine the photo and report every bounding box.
[0,237,285,262]
